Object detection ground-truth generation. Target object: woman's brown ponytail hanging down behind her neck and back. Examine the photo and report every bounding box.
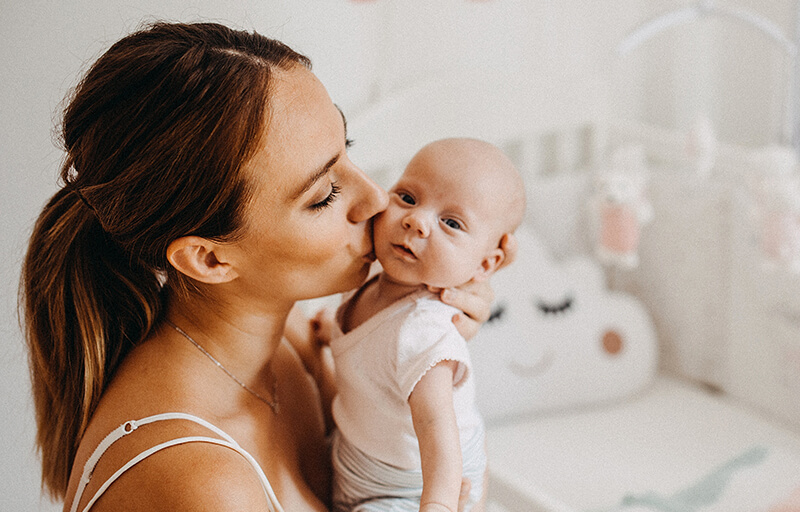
[22,189,162,495]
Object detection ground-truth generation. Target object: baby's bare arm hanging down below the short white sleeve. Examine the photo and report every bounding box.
[408,361,462,512]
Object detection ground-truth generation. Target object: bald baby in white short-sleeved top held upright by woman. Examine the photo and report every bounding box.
[327,139,525,512]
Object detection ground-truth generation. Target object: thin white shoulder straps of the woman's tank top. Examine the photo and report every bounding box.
[70,412,283,512]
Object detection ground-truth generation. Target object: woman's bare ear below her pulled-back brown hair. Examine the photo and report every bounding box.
[167,236,237,284]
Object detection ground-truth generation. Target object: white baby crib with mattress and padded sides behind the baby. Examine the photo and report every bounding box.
[348,26,800,506]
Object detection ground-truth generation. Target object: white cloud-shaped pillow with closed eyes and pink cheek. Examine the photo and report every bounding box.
[469,229,656,421]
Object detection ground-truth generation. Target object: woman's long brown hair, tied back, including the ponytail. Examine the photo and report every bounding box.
[21,23,310,498]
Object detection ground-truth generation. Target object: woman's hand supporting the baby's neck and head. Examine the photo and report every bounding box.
[429,233,519,340]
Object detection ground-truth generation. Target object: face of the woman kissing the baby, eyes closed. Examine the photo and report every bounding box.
[231,66,388,300]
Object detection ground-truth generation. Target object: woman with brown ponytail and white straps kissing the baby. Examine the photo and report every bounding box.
[23,24,513,511]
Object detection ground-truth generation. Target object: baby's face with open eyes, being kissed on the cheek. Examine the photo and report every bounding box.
[375,145,503,287]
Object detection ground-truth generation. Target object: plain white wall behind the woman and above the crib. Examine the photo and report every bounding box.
[0,0,794,510]
